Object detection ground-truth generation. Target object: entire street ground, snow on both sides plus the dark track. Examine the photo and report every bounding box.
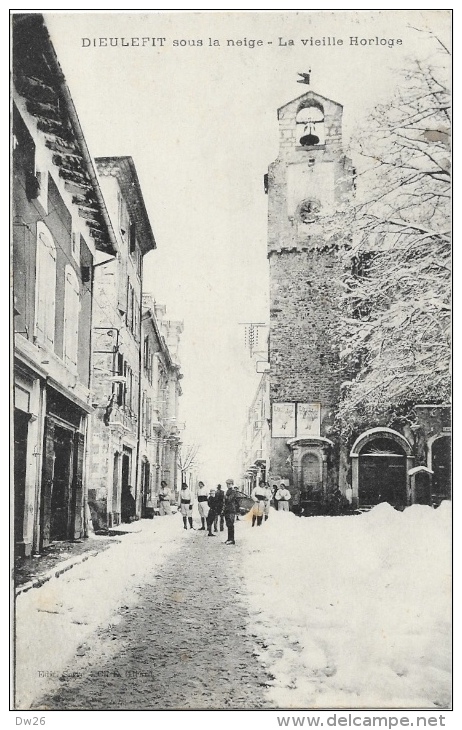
[17,503,451,709]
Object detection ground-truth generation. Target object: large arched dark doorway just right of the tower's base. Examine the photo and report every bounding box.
[350,428,414,509]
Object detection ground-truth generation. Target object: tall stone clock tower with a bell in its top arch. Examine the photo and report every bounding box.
[267,86,354,505]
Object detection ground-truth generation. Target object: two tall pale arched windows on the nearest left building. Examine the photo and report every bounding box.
[35,221,80,368]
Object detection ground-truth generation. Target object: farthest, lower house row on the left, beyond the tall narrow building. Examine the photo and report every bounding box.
[140,294,183,517]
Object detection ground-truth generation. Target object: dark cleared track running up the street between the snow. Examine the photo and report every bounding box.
[38,531,272,710]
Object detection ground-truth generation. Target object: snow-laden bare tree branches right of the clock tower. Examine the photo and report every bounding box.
[337,44,451,438]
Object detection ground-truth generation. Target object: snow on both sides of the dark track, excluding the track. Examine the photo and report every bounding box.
[16,503,451,709]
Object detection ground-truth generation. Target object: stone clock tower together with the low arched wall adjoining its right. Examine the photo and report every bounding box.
[266,91,450,513]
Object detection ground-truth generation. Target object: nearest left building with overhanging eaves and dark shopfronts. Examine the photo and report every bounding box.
[12,14,116,556]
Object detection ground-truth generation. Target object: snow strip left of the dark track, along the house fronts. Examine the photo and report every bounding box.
[15,515,189,709]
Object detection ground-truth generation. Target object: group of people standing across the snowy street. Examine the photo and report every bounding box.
[155,479,291,545]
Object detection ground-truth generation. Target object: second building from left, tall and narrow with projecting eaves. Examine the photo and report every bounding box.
[88,157,156,528]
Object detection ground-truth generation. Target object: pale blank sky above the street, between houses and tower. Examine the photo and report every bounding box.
[39,10,451,484]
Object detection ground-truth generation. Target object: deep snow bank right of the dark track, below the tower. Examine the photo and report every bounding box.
[237,502,451,709]
